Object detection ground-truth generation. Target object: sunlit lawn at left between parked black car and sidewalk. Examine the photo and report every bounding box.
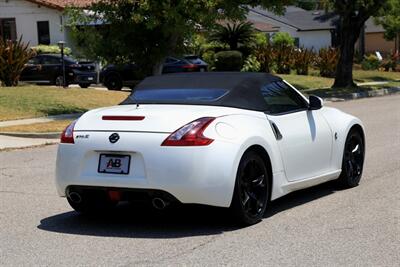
[0,86,129,121]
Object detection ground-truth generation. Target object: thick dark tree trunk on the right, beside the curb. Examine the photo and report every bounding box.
[333,17,364,88]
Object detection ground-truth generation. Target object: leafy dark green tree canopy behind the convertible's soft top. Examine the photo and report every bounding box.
[69,0,292,74]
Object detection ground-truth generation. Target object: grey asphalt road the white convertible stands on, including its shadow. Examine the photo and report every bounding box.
[0,95,400,266]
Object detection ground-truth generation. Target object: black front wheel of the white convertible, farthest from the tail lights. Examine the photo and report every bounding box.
[338,130,365,188]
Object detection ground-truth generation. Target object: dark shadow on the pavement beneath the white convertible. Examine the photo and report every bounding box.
[37,182,336,239]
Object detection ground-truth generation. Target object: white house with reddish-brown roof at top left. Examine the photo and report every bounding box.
[0,0,92,46]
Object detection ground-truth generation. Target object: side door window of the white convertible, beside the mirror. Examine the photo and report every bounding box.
[261,81,307,114]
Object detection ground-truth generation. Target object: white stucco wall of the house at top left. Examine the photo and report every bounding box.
[0,0,64,46]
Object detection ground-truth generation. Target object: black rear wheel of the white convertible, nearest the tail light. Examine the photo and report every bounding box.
[230,151,270,225]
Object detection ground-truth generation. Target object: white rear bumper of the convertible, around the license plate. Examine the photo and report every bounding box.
[56,132,239,207]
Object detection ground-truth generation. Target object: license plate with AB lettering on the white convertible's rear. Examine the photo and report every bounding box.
[98,154,131,174]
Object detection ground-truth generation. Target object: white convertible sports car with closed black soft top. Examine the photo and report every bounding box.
[56,72,365,224]
